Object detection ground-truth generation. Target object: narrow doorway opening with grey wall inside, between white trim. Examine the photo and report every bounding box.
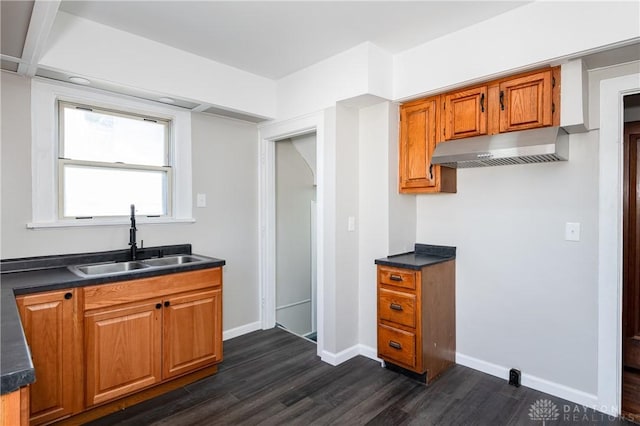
[274,133,317,342]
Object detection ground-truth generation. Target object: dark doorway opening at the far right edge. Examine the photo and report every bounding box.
[622,94,640,422]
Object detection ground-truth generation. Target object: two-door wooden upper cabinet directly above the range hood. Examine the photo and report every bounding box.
[438,67,560,141]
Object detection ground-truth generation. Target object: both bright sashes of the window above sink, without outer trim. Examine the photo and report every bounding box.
[58,101,172,219]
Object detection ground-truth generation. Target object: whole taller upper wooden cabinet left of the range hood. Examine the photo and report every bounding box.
[399,96,456,193]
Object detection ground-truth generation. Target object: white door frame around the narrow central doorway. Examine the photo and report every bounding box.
[258,112,326,356]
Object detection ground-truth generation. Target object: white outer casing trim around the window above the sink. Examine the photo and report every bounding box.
[27,78,195,229]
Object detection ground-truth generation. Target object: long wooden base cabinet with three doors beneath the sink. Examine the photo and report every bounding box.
[16,268,223,425]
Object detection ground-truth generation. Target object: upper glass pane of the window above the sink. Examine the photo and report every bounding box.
[61,105,168,166]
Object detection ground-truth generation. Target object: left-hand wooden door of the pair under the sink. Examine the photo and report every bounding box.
[85,300,162,405]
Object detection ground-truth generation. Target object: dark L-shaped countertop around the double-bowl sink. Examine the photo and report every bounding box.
[0,244,226,395]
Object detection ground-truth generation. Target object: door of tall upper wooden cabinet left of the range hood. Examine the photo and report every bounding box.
[400,97,438,191]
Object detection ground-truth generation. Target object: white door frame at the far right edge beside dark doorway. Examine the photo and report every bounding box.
[595,74,640,415]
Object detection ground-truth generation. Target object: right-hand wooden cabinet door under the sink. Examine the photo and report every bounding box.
[162,289,222,379]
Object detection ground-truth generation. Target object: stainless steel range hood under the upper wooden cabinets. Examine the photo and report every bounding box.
[431,127,569,168]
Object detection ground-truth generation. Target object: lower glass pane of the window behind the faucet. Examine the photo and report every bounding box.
[63,164,167,217]
